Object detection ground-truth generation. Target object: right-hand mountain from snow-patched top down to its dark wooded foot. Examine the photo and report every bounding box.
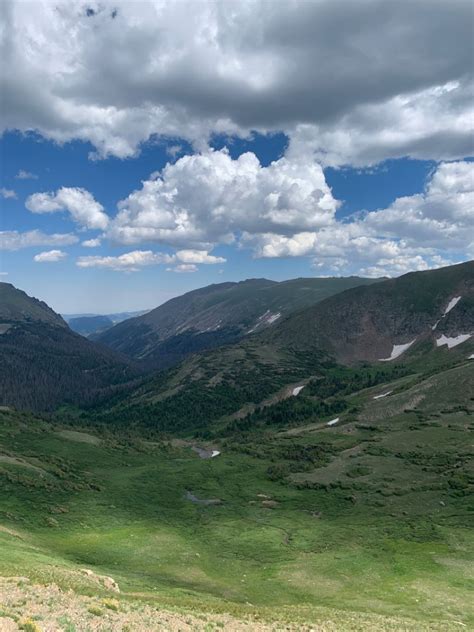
[90,262,474,433]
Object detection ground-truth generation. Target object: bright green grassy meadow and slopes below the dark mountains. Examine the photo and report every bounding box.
[0,361,474,631]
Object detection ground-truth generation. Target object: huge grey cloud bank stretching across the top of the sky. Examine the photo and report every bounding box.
[0,0,473,164]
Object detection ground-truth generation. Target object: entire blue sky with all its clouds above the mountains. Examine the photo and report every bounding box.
[0,0,474,313]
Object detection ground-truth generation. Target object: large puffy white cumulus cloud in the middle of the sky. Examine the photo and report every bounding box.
[107,149,338,247]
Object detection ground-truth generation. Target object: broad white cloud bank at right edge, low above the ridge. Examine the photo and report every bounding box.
[241,161,474,276]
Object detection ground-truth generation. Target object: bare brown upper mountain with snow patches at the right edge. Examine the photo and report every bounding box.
[265,261,474,364]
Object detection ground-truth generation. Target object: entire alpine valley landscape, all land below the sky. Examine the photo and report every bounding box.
[0,261,474,632]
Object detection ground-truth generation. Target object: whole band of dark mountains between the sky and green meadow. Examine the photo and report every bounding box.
[0,262,474,418]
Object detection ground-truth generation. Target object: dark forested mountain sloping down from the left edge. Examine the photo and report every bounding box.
[0,283,138,411]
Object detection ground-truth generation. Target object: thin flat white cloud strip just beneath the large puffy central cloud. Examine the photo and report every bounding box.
[76,250,225,272]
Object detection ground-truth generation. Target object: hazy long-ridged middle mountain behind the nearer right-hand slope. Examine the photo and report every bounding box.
[93,277,378,368]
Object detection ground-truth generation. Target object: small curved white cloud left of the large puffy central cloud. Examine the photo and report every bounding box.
[25,187,109,230]
